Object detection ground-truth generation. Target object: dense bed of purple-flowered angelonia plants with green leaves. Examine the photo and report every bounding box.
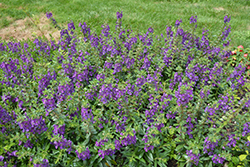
[0,12,250,167]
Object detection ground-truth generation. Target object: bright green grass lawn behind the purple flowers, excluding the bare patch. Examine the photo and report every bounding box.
[0,0,250,50]
